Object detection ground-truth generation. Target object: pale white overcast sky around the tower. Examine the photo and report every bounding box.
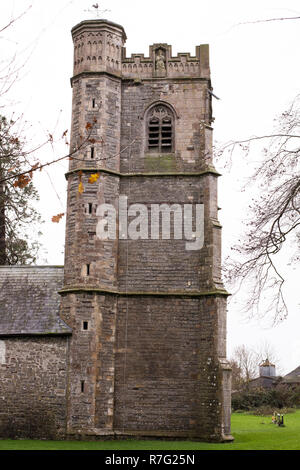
[0,0,300,373]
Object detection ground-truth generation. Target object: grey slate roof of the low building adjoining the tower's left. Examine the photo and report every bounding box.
[0,266,72,336]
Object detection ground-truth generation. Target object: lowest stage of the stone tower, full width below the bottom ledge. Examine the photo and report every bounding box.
[61,292,230,440]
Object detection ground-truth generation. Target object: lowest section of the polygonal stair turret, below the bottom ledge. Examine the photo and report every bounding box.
[61,292,117,435]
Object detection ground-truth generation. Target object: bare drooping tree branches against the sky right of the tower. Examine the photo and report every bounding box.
[218,95,300,323]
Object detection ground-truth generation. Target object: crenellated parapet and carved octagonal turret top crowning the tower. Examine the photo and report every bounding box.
[72,20,210,79]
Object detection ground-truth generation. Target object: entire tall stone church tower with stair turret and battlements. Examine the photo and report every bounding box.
[60,20,231,441]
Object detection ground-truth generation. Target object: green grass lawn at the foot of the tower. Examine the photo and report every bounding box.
[0,410,300,450]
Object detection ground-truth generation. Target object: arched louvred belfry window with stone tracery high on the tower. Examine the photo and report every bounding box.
[147,104,174,153]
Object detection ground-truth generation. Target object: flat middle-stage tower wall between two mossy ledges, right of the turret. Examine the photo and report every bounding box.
[118,175,220,292]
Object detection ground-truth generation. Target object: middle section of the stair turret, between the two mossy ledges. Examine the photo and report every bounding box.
[65,172,119,289]
